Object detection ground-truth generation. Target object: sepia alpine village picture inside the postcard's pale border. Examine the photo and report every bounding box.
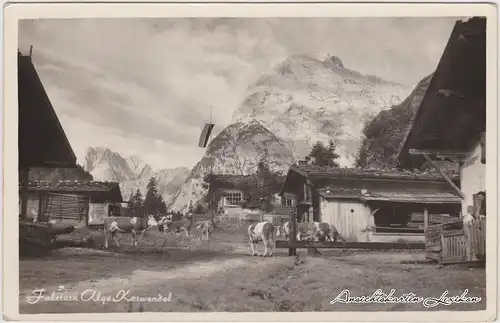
[4,5,498,320]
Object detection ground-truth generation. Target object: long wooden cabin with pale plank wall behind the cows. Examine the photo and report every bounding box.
[280,165,460,242]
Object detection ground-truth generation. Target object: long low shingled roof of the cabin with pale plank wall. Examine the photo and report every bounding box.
[290,165,459,182]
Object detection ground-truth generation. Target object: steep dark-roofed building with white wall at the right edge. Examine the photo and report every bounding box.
[399,17,486,213]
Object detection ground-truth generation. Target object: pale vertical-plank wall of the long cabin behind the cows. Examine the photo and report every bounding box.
[320,198,375,242]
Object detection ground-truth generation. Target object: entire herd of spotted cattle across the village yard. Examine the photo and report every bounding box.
[104,213,345,256]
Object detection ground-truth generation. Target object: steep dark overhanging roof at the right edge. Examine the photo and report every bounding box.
[399,17,486,168]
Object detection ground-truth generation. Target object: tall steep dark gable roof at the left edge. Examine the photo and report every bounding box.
[17,52,76,168]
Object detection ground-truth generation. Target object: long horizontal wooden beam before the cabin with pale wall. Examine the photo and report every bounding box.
[276,240,425,250]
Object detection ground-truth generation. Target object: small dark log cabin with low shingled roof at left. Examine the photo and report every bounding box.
[20,180,123,227]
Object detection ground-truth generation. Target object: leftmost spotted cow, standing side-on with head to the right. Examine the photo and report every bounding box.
[104,215,158,248]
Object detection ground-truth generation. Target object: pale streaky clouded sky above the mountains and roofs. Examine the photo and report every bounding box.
[19,17,459,169]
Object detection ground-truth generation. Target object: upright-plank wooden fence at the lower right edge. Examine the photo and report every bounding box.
[425,219,486,264]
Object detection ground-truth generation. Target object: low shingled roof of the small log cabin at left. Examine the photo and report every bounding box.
[23,180,123,202]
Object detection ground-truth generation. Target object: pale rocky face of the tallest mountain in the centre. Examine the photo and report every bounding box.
[233,55,410,166]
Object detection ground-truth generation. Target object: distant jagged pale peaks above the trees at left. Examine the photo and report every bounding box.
[84,147,189,204]
